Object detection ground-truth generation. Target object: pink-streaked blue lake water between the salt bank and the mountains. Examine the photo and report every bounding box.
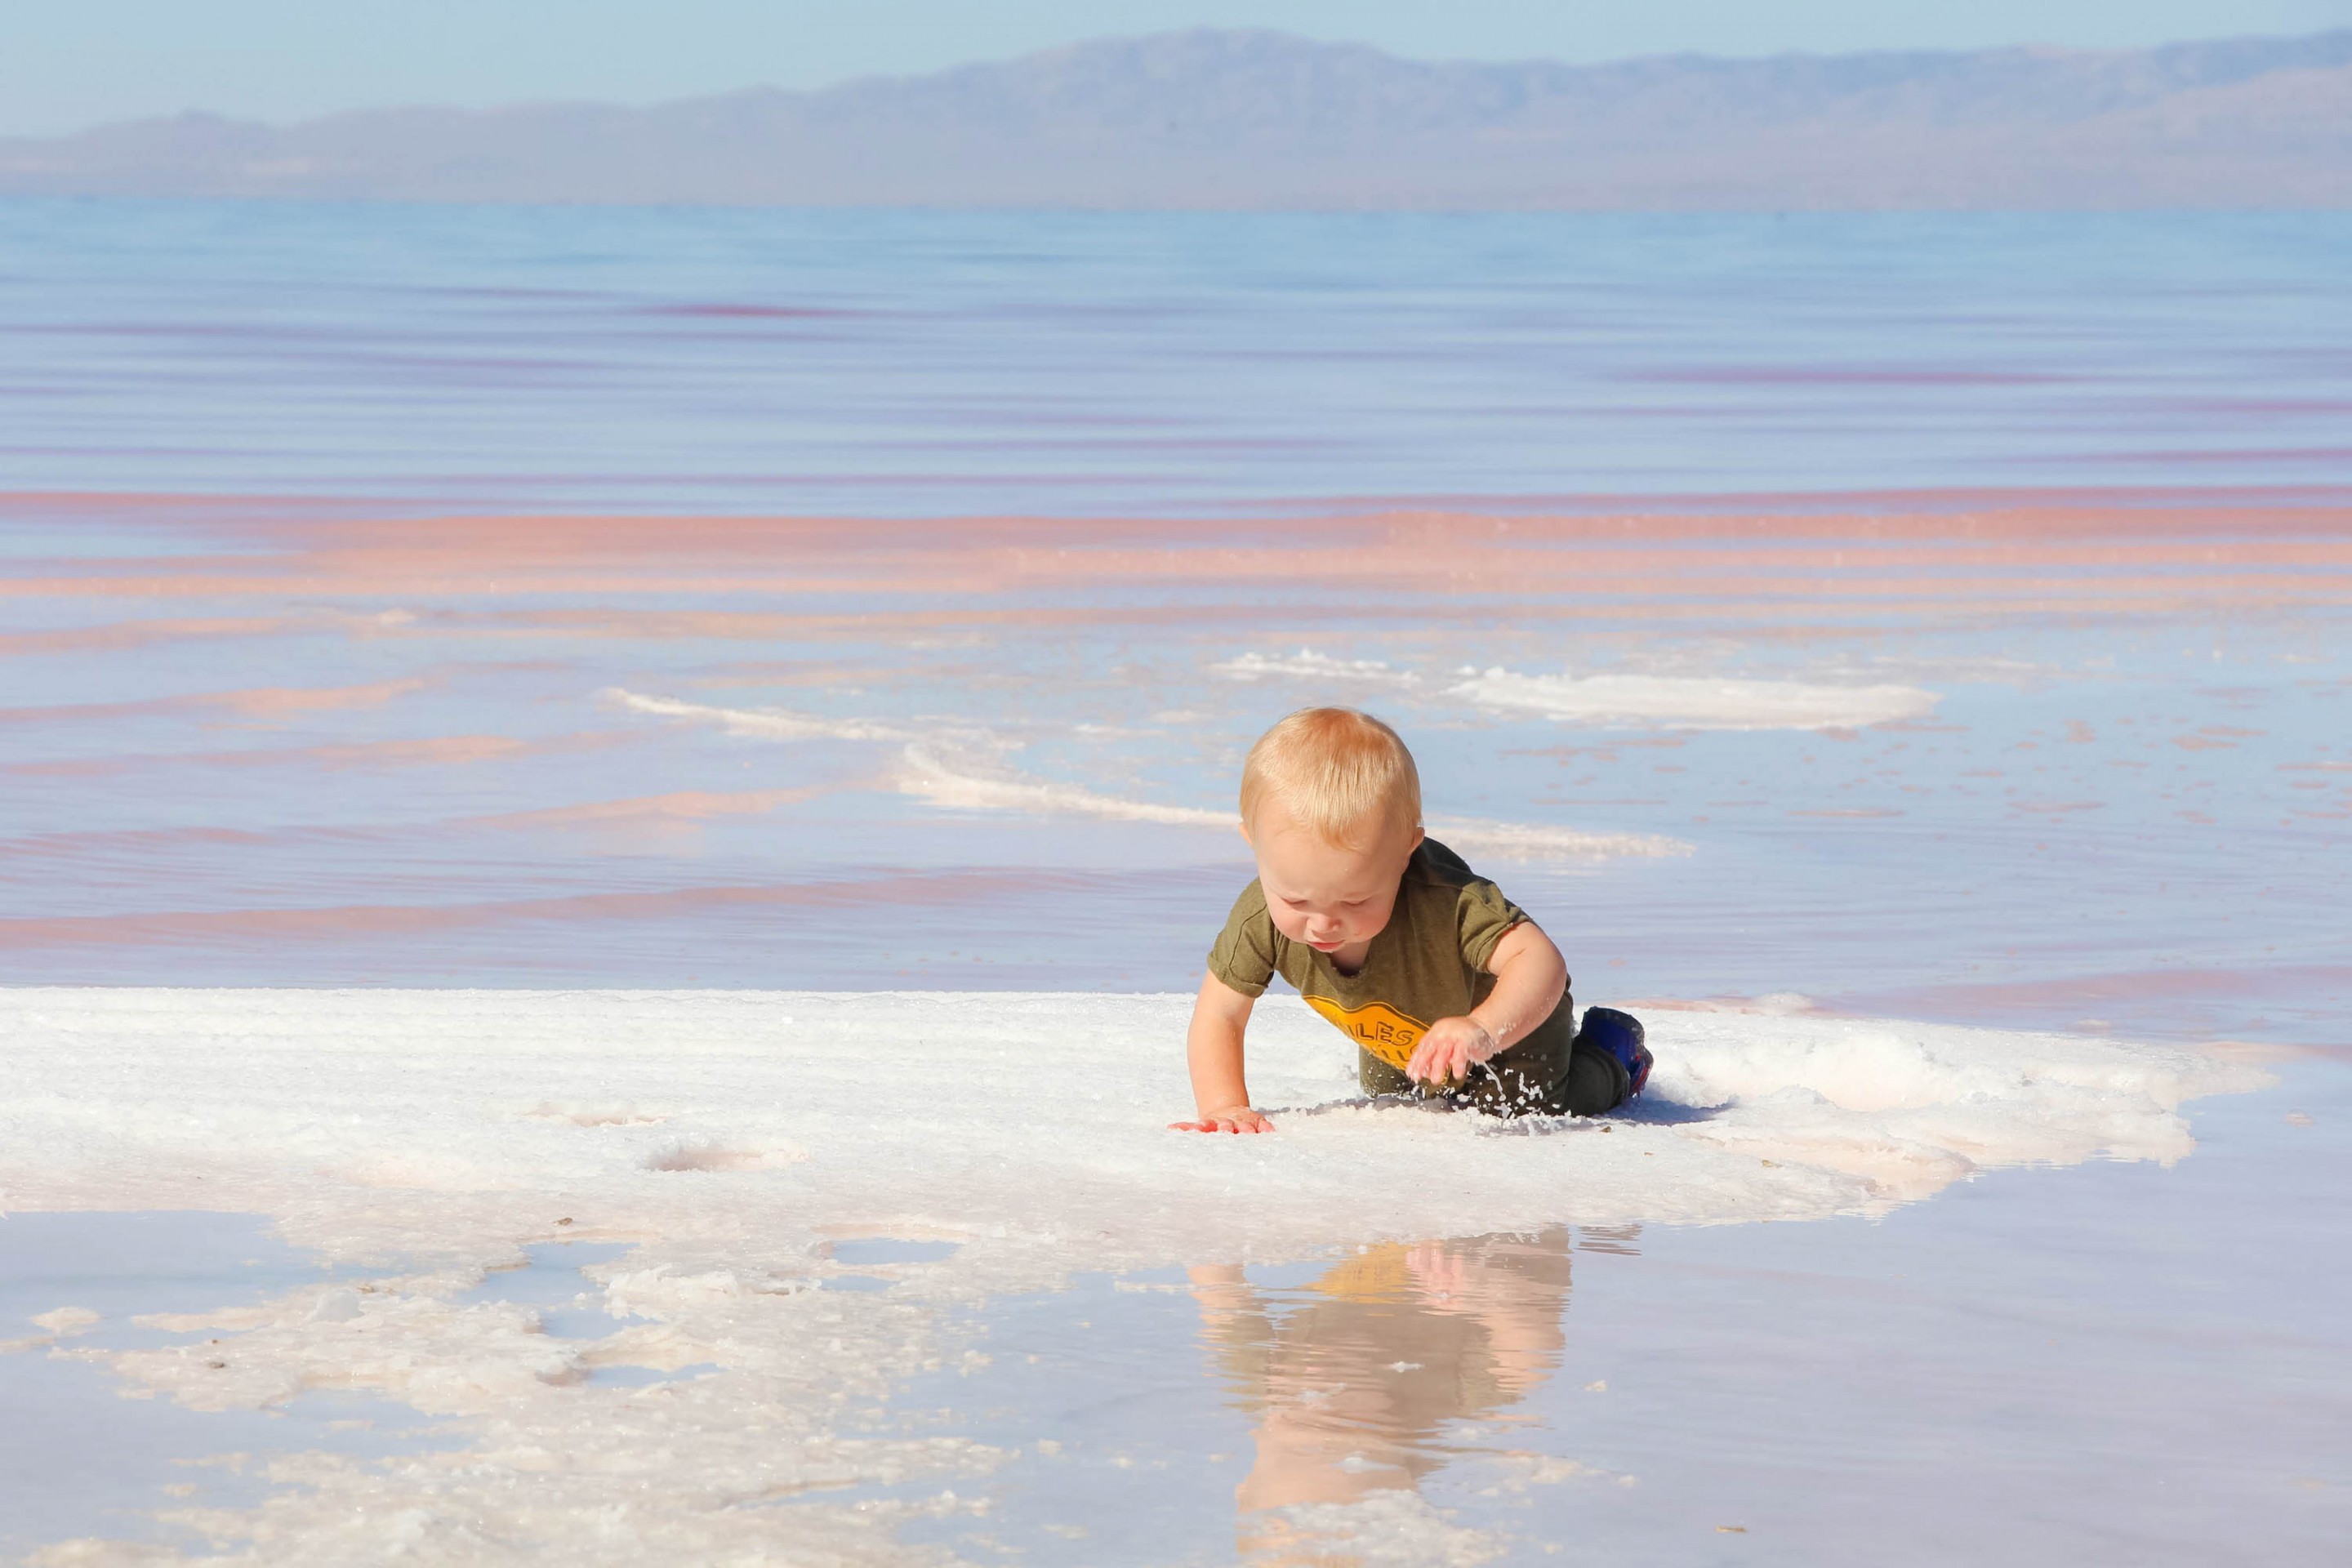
[0,203,2352,1039]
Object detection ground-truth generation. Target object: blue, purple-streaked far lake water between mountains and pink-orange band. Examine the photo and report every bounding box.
[0,200,2352,517]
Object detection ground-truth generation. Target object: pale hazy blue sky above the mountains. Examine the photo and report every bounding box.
[0,0,2352,134]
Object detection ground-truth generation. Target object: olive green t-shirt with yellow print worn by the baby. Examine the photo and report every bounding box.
[1209,840,1576,1094]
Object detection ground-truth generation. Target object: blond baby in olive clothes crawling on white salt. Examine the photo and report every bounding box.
[1174,707,1651,1133]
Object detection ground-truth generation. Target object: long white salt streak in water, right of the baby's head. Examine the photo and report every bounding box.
[1446,668,1940,728]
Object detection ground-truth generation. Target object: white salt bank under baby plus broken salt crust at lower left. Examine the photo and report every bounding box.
[0,990,2265,1563]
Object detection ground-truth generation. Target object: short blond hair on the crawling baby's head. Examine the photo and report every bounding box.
[1242,707,1421,849]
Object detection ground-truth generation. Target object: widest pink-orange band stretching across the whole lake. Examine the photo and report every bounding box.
[0,496,2352,616]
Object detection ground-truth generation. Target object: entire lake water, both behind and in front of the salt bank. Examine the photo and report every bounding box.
[0,203,2352,1563]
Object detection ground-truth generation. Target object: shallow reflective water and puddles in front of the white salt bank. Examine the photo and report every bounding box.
[0,1060,2352,1563]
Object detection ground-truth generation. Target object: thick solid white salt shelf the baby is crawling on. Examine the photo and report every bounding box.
[0,987,2265,1278]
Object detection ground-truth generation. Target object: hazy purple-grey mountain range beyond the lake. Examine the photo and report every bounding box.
[0,30,2352,212]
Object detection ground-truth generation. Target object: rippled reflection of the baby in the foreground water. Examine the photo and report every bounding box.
[1192,1227,1569,1552]
